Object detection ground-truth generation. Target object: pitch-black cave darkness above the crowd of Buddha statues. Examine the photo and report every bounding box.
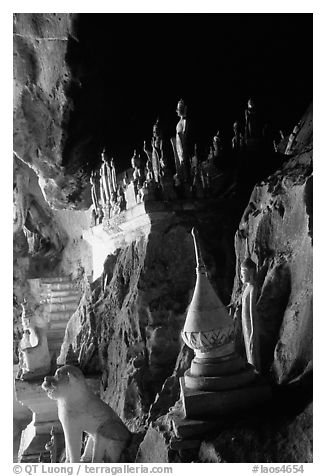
[59,13,312,175]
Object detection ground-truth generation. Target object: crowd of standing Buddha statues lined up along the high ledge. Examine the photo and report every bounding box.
[90,99,299,225]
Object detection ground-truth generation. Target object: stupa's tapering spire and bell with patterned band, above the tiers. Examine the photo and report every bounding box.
[182,229,234,352]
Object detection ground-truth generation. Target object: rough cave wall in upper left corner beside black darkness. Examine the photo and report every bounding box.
[14,13,90,208]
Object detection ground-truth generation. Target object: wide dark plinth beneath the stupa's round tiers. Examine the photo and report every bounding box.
[180,374,272,420]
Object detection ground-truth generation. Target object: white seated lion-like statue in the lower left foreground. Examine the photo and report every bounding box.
[42,365,131,463]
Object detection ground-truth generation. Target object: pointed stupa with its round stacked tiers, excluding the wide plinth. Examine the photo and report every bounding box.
[181,229,256,391]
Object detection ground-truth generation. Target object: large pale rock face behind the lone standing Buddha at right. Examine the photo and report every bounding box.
[233,104,312,383]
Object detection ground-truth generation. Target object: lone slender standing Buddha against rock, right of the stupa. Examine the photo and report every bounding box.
[240,257,260,372]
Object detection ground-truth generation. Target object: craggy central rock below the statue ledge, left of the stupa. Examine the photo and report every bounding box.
[59,201,244,429]
